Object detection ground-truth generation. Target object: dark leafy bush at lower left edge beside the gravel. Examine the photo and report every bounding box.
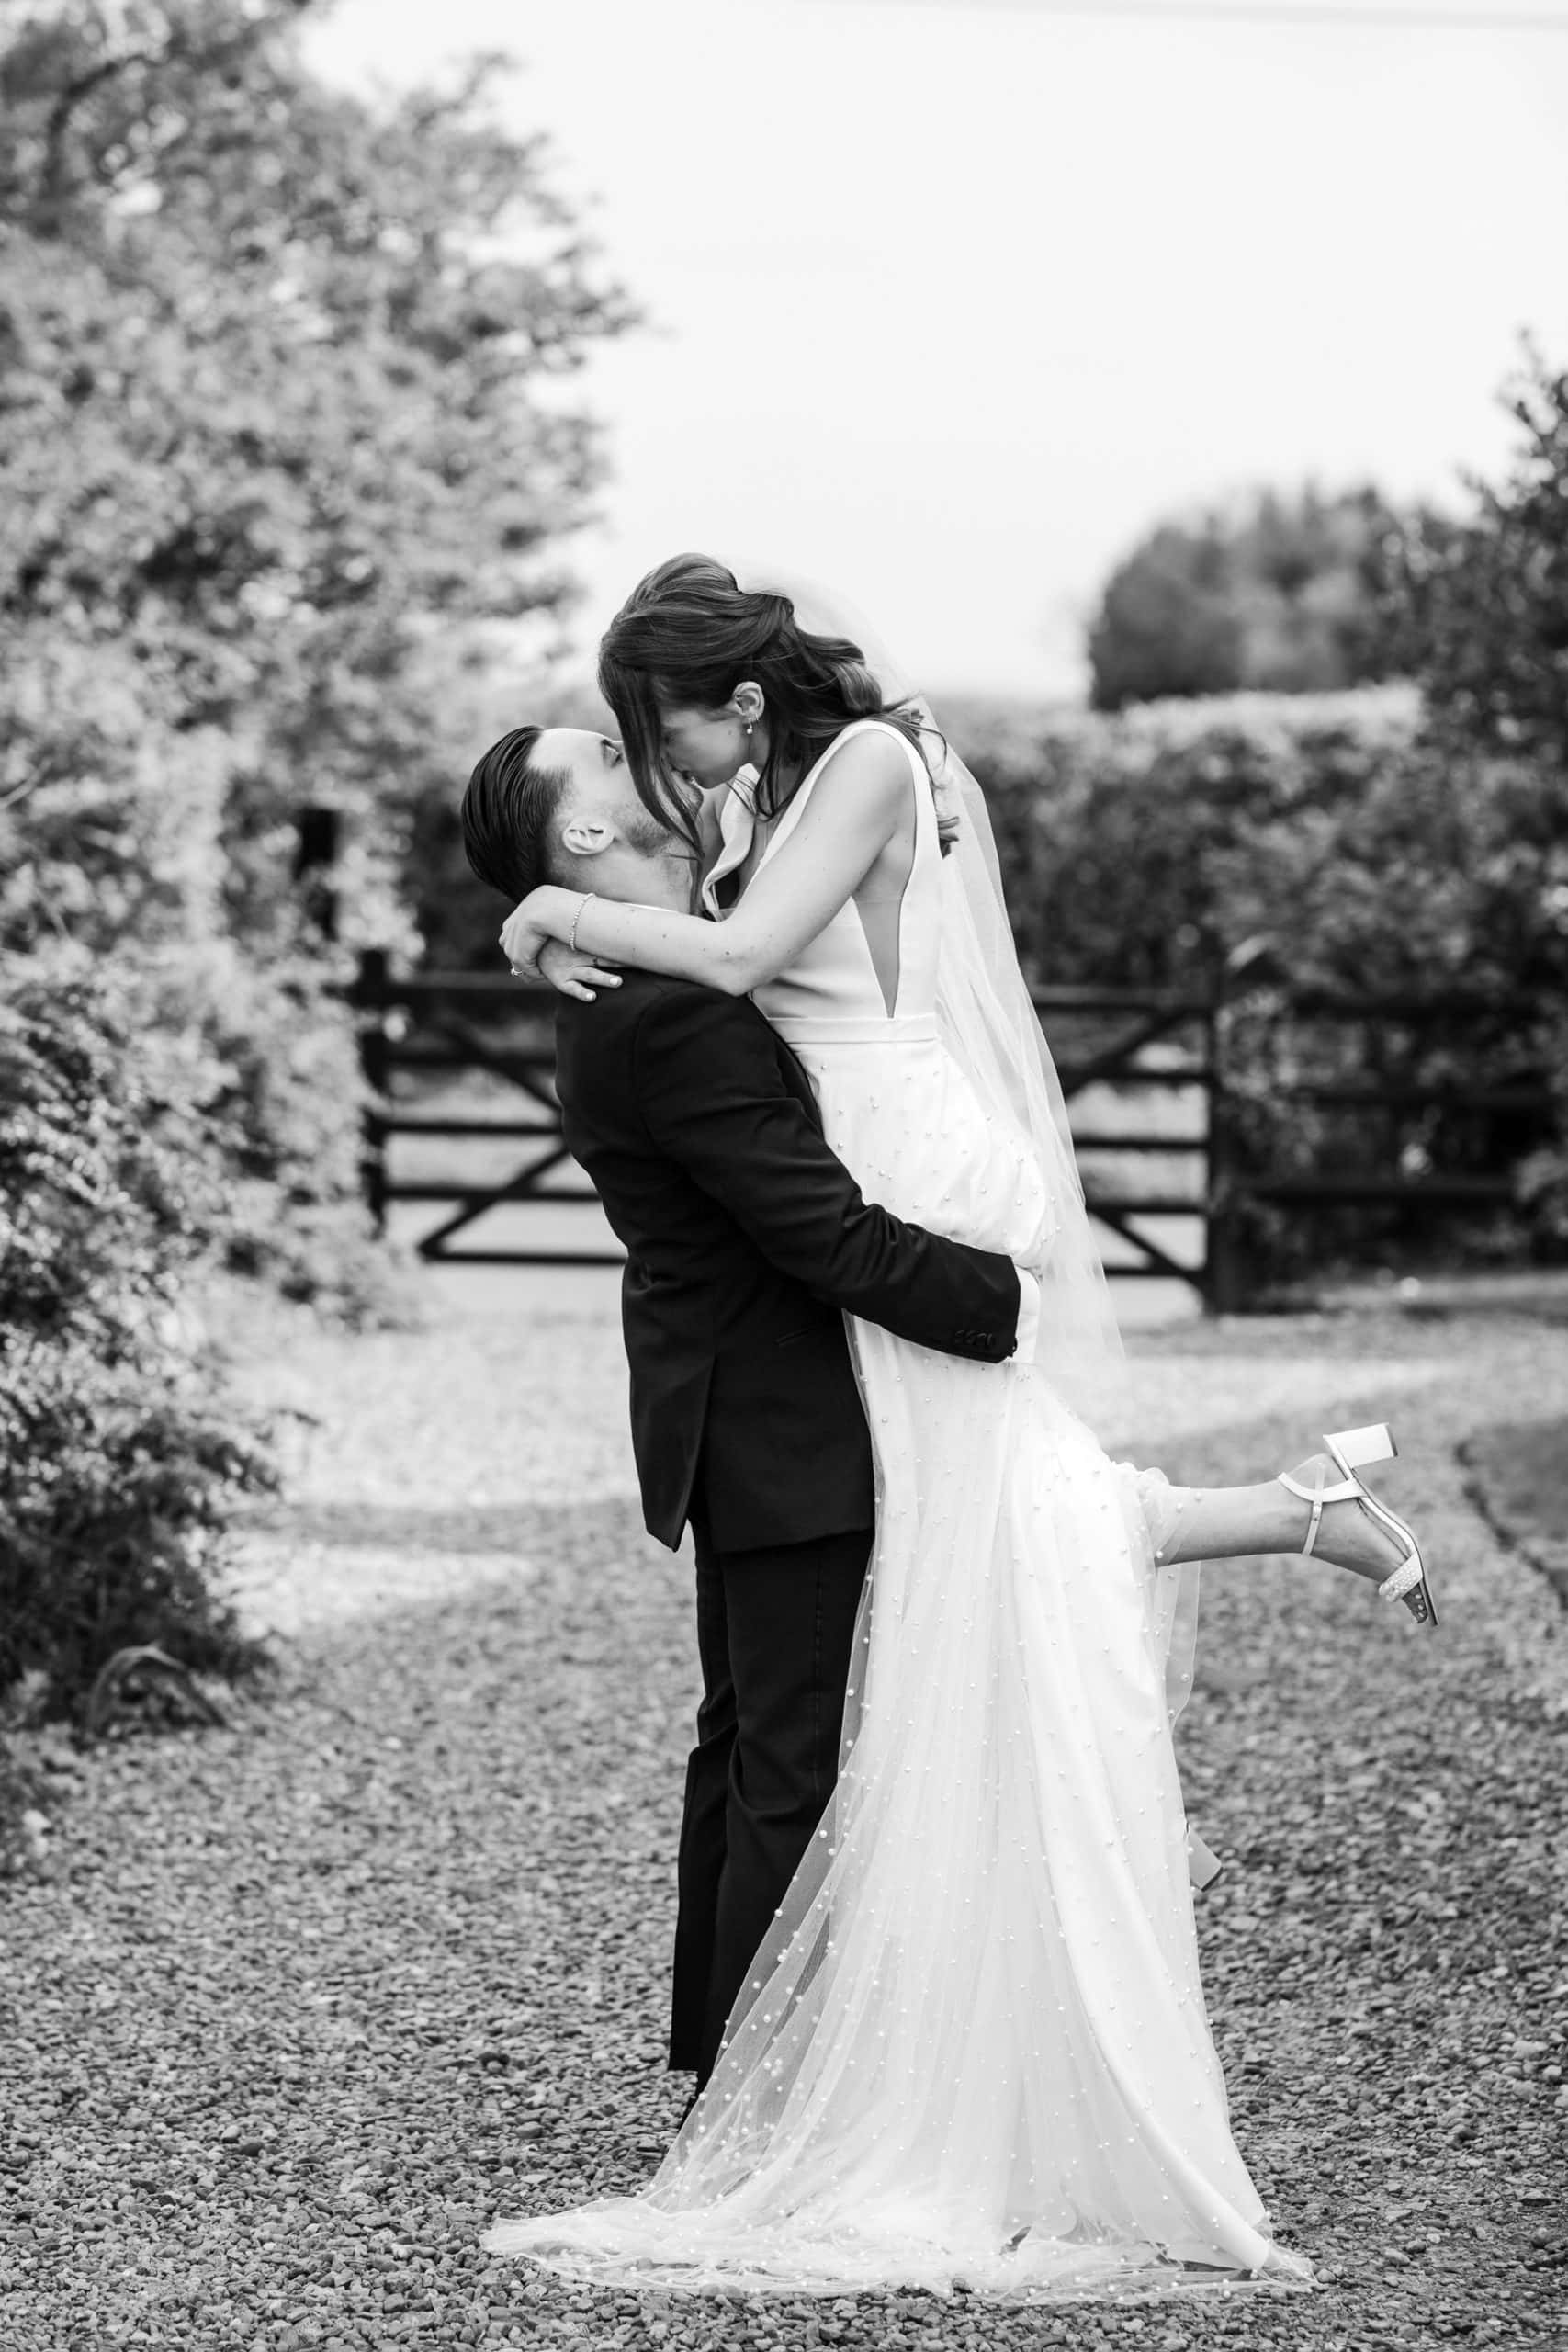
[0,976,273,1713]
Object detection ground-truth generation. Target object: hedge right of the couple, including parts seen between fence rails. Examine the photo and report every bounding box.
[947,687,1568,1282]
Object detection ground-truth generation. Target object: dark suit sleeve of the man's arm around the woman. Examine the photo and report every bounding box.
[632,988,1021,1362]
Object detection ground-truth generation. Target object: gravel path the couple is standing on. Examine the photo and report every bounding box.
[0,1277,1568,2352]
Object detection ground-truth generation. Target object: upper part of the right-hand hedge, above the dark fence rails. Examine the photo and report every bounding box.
[950,687,1568,995]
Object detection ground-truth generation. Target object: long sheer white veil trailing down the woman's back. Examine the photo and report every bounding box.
[722,558,1126,1416]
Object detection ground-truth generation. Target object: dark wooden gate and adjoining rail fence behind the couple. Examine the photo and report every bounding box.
[355,953,1551,1307]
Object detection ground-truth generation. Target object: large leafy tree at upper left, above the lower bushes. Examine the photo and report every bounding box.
[0,0,632,945]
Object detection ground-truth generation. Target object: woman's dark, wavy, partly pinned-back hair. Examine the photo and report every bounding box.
[600,555,947,849]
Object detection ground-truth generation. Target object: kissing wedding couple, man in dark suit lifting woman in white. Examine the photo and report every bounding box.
[453,558,1434,2301]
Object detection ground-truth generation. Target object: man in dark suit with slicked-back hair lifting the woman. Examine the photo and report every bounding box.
[463,727,1039,2088]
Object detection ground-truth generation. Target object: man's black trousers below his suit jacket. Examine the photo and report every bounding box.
[670,1521,872,2082]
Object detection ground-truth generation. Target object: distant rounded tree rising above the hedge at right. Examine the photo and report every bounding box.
[1089,489,1396,710]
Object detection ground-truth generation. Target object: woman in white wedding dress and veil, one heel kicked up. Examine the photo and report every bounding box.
[487,555,1434,2301]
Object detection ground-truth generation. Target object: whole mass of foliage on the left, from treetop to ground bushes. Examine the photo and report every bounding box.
[0,0,632,1778]
